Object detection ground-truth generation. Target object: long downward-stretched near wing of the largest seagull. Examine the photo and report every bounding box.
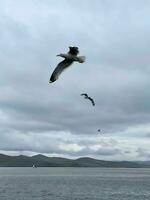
[49,59,73,83]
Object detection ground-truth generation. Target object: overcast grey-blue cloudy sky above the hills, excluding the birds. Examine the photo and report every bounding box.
[0,0,150,160]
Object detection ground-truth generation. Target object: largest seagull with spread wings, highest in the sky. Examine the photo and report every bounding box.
[49,47,85,83]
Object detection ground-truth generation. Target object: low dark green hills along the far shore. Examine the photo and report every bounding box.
[0,154,150,168]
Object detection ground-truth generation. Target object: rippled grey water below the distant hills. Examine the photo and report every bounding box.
[0,168,150,200]
